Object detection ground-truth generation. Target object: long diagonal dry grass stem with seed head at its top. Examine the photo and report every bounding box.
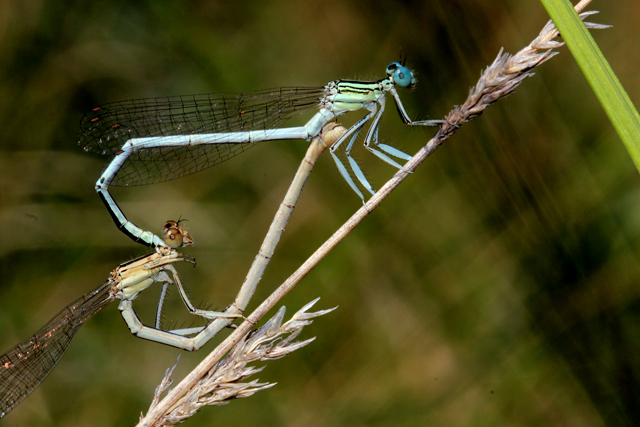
[139,0,608,426]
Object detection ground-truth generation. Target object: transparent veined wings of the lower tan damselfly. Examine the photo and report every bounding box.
[0,281,113,418]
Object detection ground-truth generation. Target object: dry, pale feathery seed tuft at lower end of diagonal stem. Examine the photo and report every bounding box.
[144,298,335,426]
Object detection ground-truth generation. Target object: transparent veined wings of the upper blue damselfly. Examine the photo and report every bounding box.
[78,88,325,186]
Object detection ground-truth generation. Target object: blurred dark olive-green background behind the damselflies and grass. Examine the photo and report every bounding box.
[0,0,640,427]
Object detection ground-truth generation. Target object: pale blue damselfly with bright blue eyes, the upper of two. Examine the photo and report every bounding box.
[78,62,442,247]
